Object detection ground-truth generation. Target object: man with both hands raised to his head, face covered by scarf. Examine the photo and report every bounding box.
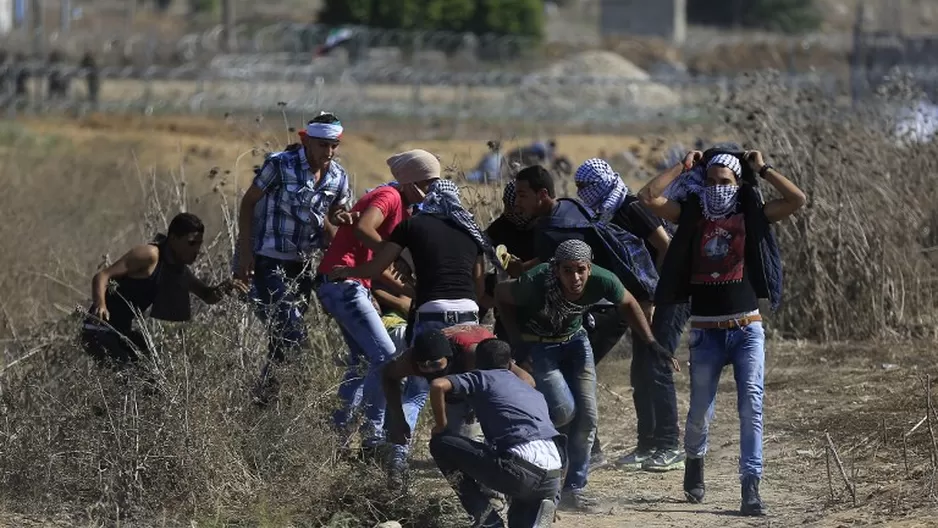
[639,149,806,515]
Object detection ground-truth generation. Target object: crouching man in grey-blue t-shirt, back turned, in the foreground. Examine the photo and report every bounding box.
[430,339,566,528]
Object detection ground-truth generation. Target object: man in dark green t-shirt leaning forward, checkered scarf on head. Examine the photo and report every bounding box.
[495,239,679,512]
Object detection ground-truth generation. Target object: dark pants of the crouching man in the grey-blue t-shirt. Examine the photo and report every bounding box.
[430,434,564,528]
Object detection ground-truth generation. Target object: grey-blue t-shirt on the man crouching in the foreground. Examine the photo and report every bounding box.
[446,369,559,453]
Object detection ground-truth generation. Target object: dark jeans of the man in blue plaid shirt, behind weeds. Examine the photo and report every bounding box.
[253,255,313,363]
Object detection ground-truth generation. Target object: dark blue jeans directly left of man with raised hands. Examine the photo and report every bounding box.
[629,304,690,450]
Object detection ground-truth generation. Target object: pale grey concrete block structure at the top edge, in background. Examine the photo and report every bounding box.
[599,0,687,44]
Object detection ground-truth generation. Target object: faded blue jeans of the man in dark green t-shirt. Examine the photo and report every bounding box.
[525,329,598,489]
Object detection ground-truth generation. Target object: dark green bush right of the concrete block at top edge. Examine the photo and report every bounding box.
[687,0,821,33]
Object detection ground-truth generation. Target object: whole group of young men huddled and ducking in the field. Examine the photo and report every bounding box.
[83,109,806,527]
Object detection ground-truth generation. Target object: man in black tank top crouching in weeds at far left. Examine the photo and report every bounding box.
[81,213,247,367]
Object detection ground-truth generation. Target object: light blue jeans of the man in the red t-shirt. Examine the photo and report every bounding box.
[316,280,396,446]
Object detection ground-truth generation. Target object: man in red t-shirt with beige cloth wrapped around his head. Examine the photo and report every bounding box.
[315,150,441,449]
